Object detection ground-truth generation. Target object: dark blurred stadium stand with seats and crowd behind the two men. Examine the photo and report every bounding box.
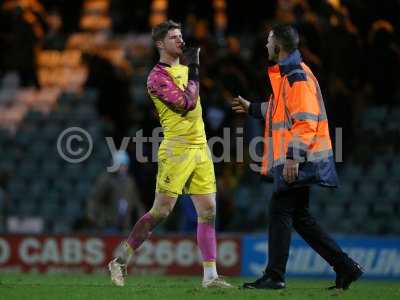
[0,0,400,235]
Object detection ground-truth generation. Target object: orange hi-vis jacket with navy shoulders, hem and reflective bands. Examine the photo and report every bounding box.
[261,50,338,190]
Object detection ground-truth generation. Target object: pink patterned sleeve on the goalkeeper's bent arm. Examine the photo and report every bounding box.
[147,66,200,111]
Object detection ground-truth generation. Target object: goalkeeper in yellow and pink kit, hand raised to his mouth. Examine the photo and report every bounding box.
[109,21,232,288]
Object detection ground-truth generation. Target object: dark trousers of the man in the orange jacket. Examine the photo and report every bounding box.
[265,187,350,281]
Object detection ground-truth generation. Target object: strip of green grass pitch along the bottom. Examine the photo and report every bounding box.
[0,273,400,300]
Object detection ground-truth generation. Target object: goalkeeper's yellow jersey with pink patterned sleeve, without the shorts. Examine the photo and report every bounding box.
[147,63,207,146]
